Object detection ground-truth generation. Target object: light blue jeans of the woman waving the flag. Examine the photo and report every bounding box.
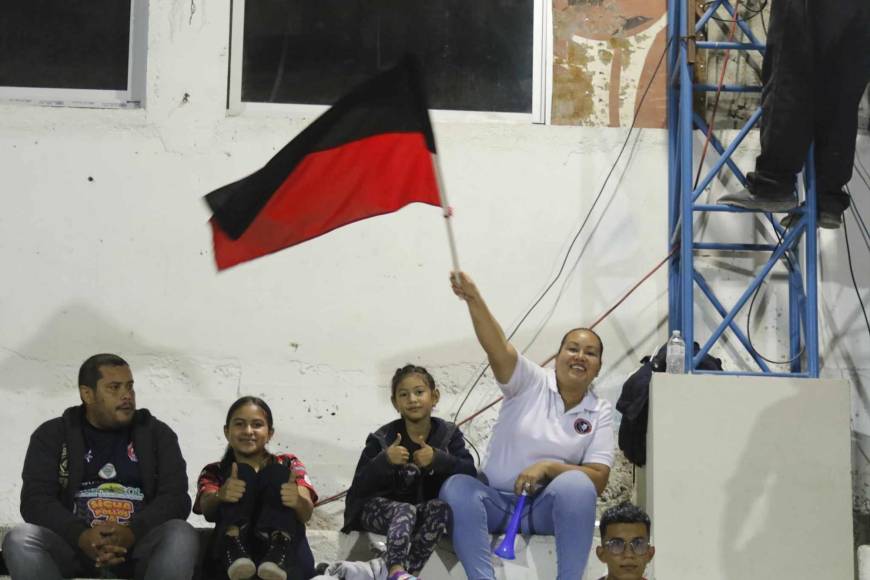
[439,471,597,580]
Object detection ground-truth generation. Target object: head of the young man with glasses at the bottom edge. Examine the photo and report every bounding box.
[595,502,656,580]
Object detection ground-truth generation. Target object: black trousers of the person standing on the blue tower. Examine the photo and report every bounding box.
[750,0,870,213]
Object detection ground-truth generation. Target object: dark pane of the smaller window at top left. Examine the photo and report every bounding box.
[0,0,130,91]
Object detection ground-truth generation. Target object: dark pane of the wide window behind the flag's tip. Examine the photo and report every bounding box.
[242,0,534,113]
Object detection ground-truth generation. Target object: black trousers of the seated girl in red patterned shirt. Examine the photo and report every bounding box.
[214,463,314,578]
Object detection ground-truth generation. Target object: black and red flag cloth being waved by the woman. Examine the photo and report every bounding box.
[205,58,440,270]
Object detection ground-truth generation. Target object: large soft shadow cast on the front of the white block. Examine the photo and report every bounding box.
[724,390,852,578]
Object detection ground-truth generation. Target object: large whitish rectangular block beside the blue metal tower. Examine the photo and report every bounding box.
[646,373,854,580]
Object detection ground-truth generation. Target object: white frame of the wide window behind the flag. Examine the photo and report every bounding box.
[227,0,553,124]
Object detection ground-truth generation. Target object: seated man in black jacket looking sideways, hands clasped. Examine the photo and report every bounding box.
[3,354,198,580]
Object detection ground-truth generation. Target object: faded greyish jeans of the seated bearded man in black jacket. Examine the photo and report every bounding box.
[3,520,199,580]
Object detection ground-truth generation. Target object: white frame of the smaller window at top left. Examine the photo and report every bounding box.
[0,0,149,109]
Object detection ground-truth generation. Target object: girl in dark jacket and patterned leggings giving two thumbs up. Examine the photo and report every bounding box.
[342,364,477,580]
